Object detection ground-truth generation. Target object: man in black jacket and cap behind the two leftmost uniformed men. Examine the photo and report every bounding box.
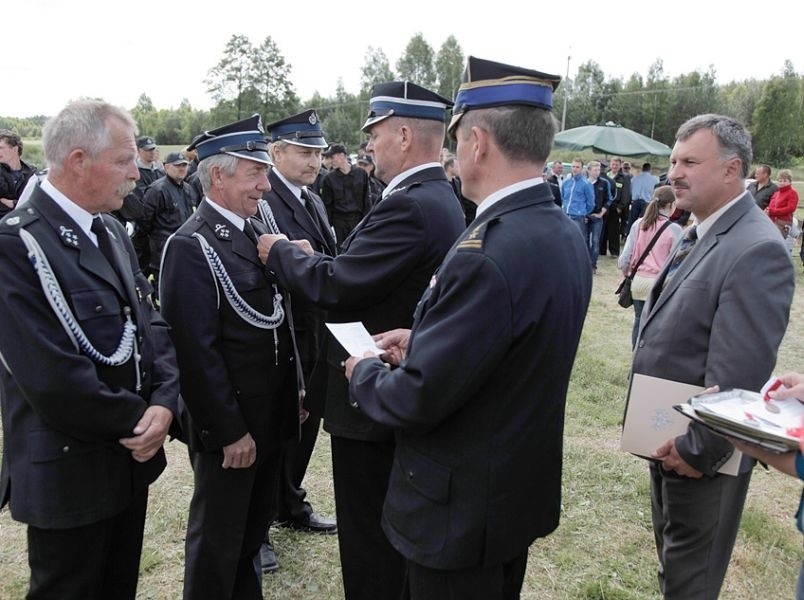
[136,152,201,296]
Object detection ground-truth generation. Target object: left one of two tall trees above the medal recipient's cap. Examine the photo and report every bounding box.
[204,35,254,120]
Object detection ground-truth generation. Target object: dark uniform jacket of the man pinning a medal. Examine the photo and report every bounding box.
[268,166,465,441]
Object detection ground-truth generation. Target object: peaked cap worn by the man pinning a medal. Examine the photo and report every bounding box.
[361,81,452,131]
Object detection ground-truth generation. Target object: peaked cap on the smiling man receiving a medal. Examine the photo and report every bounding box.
[187,115,274,165]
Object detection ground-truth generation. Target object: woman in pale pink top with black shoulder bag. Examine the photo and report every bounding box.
[617,185,682,347]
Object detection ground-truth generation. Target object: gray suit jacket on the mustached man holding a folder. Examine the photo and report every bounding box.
[632,193,794,475]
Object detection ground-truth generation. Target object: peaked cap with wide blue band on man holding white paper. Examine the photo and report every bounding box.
[447,56,561,135]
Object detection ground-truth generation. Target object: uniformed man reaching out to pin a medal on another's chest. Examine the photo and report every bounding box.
[260,81,464,600]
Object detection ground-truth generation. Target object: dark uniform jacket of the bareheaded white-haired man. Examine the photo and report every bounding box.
[0,187,178,529]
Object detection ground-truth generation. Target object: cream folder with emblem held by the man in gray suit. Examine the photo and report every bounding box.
[620,373,743,475]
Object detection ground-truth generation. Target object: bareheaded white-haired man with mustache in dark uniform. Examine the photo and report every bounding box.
[0,100,179,600]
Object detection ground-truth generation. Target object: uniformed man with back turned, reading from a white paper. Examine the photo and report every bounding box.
[346,57,592,600]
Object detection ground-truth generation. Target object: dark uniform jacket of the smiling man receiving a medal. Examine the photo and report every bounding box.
[160,199,298,452]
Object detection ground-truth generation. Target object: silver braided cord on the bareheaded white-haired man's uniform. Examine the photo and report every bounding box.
[20,229,142,391]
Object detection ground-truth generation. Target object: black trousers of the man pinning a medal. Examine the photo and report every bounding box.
[330,435,405,600]
